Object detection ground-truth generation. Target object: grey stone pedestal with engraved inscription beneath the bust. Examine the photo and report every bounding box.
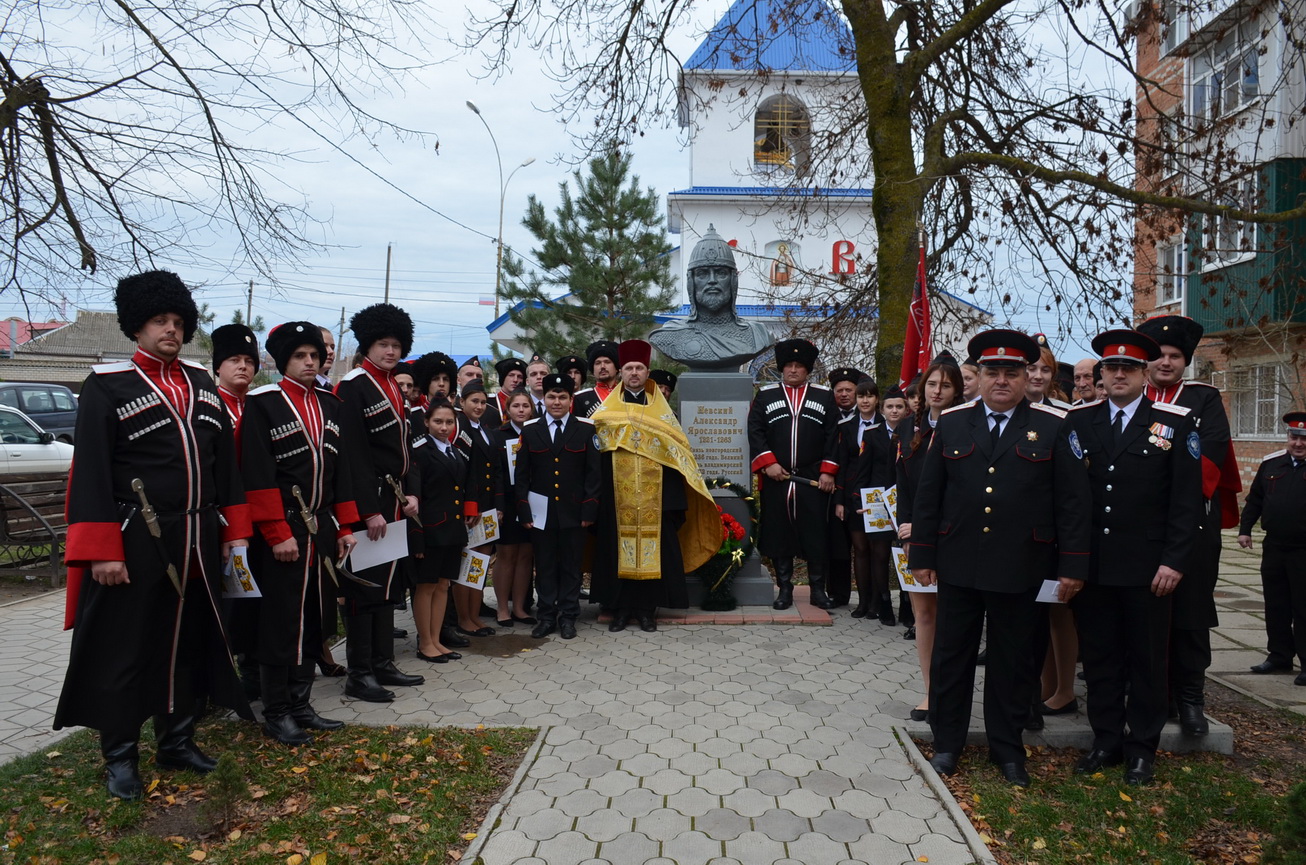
[675,372,776,606]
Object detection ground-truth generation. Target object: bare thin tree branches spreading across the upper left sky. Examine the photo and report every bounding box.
[0,0,436,301]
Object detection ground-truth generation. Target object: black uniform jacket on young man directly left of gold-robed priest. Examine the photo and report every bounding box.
[513,414,601,529]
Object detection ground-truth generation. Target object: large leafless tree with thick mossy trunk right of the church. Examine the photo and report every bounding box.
[469,0,1306,358]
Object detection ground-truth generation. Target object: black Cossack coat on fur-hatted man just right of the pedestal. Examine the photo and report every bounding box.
[748,384,838,566]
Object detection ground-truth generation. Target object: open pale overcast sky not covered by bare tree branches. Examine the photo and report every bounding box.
[3,0,1112,361]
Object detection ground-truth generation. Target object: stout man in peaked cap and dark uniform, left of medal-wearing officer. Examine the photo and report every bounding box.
[908,331,1092,787]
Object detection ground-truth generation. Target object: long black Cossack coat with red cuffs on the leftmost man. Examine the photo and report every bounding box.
[54,361,253,730]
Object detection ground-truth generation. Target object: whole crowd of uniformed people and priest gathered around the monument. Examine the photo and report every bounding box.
[55,270,1306,800]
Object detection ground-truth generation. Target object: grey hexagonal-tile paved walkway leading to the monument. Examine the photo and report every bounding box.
[0,527,1306,865]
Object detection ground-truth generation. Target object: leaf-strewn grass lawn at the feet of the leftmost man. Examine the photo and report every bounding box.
[0,720,535,865]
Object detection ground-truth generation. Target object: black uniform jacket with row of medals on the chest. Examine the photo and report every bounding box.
[1070,397,1202,587]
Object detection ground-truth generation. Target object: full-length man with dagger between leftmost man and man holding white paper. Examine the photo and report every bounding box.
[240,321,360,746]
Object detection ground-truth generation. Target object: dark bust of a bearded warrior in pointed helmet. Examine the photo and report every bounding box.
[649,225,774,372]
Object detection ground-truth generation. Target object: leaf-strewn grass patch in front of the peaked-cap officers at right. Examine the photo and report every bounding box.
[929,682,1306,865]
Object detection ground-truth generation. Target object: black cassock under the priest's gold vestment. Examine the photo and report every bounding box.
[589,388,690,610]
